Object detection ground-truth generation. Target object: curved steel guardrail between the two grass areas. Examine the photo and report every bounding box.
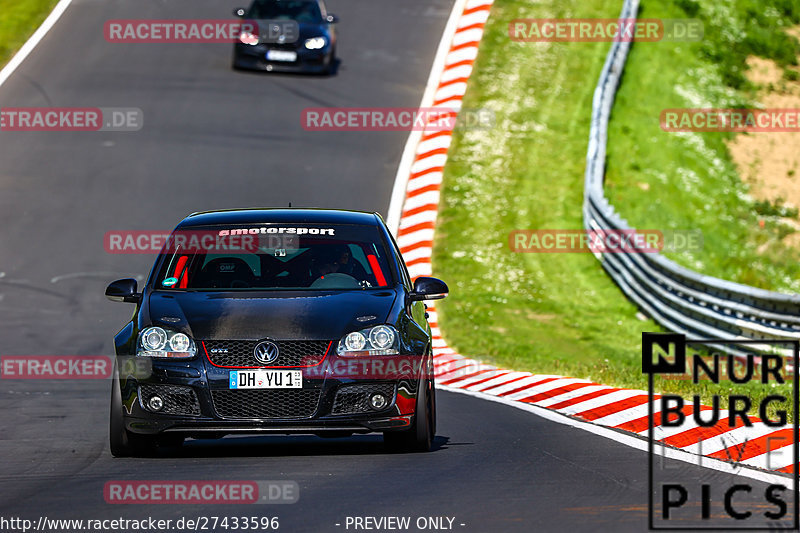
[583,0,800,355]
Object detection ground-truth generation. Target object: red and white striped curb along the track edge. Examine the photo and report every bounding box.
[389,0,794,473]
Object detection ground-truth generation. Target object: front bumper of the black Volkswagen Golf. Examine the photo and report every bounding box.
[119,356,421,437]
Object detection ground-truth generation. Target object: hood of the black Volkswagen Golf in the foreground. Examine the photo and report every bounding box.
[149,289,397,340]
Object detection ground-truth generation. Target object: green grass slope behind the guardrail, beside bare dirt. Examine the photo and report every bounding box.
[606,0,800,292]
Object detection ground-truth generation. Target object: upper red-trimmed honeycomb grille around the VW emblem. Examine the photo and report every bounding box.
[208,341,330,368]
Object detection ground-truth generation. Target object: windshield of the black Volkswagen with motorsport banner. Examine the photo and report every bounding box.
[155,224,393,291]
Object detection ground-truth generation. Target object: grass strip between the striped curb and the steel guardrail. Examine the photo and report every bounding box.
[433,0,796,416]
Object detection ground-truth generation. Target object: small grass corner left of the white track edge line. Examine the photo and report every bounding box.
[0,0,58,67]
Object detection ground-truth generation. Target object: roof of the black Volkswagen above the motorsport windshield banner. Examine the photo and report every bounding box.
[178,208,379,228]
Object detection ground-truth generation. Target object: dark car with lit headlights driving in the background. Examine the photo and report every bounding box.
[233,0,338,73]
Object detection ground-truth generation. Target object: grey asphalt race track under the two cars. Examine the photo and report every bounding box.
[0,0,788,531]
